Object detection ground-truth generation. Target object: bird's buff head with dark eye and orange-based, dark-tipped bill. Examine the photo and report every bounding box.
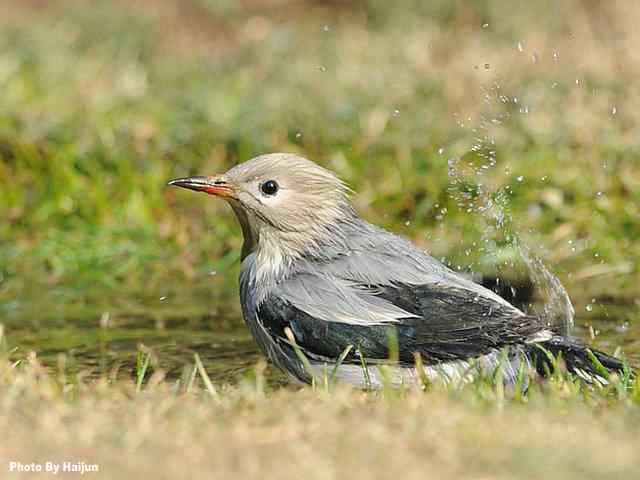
[169,153,355,258]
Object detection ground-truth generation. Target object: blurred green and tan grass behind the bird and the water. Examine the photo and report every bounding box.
[0,0,640,366]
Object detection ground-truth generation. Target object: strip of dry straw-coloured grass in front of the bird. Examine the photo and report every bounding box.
[0,360,640,479]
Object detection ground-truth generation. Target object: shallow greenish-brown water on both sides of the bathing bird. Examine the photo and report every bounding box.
[2,278,640,383]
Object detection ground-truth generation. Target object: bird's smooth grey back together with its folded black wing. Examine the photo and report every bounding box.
[258,232,550,363]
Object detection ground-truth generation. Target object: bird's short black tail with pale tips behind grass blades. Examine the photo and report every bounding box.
[530,336,635,385]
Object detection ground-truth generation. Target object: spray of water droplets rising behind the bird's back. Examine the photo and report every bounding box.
[448,83,575,334]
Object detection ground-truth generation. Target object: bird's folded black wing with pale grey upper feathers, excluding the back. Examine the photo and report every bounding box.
[258,276,545,364]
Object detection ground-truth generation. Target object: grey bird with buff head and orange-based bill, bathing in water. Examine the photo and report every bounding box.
[169,153,625,389]
